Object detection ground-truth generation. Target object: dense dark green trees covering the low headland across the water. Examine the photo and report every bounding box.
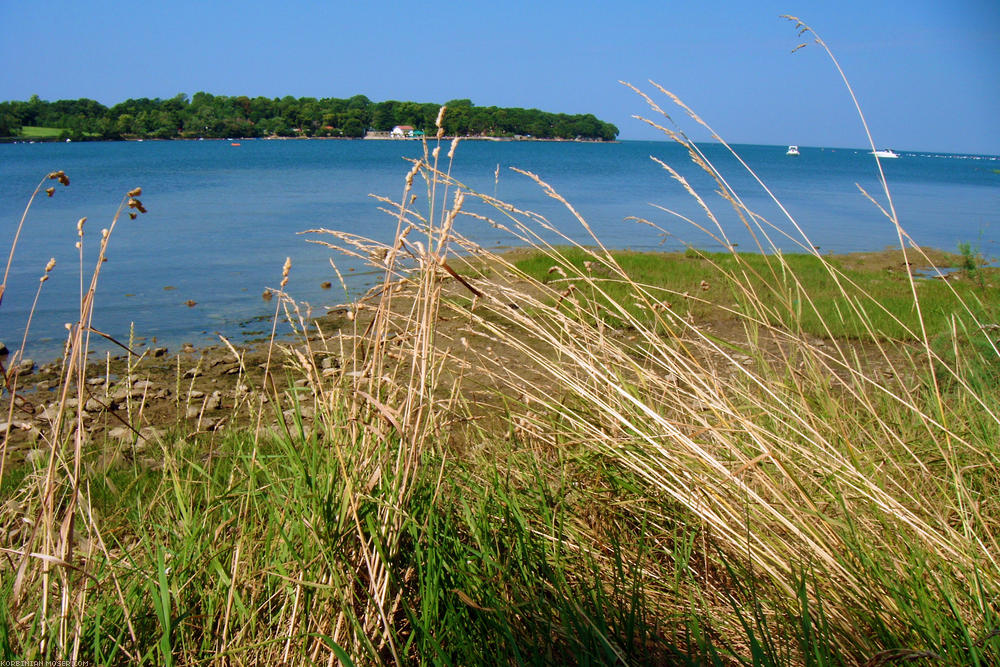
[0,92,618,141]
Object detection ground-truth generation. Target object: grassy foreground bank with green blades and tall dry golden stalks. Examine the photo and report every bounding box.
[0,74,1000,665]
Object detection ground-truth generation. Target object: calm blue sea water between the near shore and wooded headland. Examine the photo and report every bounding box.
[0,141,1000,359]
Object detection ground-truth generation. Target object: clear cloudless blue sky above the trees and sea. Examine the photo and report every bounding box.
[0,0,1000,154]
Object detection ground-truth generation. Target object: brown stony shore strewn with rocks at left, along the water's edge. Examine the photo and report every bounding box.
[0,315,352,464]
